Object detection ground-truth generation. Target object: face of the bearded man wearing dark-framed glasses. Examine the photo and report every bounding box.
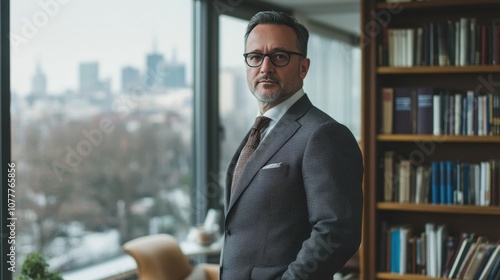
[245,24,309,108]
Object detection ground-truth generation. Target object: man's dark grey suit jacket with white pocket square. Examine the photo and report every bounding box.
[220,95,363,280]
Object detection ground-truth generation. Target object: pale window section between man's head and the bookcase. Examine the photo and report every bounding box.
[304,32,361,140]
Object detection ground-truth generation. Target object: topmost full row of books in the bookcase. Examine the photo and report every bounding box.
[378,17,500,67]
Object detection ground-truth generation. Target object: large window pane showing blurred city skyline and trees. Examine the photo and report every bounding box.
[10,0,194,272]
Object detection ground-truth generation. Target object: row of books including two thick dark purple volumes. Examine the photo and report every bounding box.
[380,87,500,136]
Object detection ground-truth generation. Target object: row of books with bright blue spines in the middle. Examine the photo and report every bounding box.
[383,151,500,206]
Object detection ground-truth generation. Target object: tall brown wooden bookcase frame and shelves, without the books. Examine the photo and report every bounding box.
[360,0,500,280]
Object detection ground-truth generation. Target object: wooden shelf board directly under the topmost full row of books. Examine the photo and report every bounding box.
[377,65,500,75]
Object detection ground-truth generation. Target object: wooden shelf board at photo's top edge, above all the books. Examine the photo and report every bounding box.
[377,0,498,9]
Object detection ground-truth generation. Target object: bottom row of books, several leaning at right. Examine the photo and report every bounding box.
[379,222,500,280]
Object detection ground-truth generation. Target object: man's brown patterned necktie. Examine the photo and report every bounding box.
[231,116,271,194]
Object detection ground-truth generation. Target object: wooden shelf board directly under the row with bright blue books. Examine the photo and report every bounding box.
[377,202,500,216]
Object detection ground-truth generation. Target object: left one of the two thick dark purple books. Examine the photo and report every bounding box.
[393,87,415,134]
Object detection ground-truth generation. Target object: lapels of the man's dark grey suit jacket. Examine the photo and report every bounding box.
[226,95,312,214]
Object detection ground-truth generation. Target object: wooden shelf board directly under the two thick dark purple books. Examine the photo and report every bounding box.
[377,134,500,143]
